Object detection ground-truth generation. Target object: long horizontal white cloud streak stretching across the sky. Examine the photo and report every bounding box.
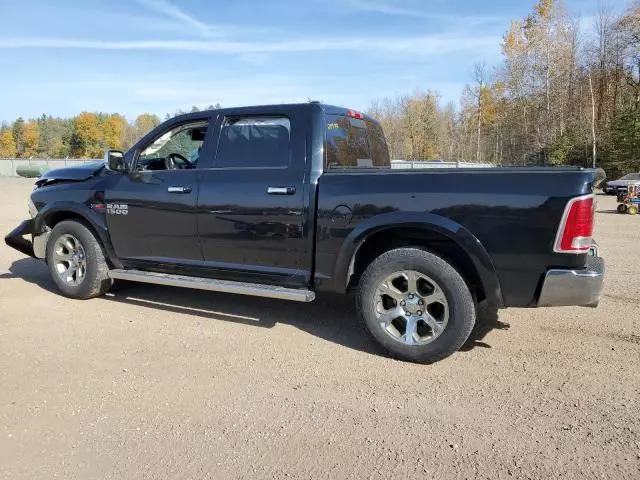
[0,35,500,55]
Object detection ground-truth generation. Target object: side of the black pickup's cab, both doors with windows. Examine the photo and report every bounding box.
[104,106,313,286]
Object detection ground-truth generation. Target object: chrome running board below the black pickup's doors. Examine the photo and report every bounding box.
[109,269,316,302]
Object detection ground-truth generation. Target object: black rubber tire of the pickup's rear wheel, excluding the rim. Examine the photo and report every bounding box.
[356,248,476,363]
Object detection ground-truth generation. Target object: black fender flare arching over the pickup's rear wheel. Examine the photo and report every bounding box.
[334,212,504,307]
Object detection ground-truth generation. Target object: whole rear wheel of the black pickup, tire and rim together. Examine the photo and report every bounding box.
[356,248,476,363]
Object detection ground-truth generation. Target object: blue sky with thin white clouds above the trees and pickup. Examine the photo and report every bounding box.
[0,0,626,121]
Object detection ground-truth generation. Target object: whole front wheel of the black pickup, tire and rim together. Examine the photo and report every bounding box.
[47,220,113,299]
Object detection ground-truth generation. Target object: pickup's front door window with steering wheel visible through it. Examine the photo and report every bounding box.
[137,121,208,171]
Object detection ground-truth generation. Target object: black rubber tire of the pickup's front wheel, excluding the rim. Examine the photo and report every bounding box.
[47,220,113,300]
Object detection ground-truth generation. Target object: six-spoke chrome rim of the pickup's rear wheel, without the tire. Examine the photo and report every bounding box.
[375,270,449,345]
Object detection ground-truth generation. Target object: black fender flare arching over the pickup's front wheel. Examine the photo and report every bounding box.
[33,201,122,268]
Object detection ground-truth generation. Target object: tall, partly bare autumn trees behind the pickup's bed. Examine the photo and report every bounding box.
[369,0,640,176]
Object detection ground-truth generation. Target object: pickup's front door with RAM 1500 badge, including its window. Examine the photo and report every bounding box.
[105,118,214,268]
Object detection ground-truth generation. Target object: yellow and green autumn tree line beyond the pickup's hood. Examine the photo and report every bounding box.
[0,104,221,158]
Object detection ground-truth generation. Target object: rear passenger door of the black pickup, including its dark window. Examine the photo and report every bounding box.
[197,106,309,285]
